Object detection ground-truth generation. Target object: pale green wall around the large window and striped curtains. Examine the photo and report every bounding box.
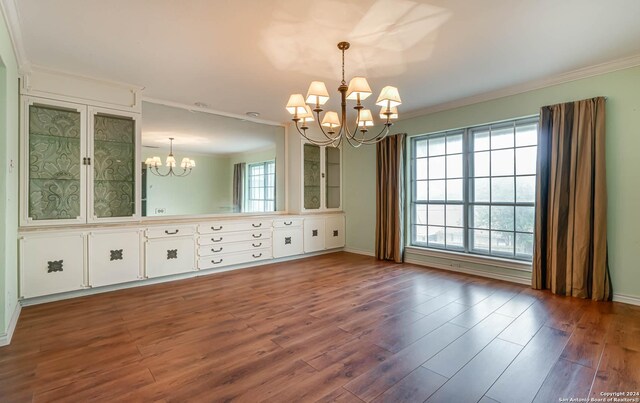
[344,67,640,297]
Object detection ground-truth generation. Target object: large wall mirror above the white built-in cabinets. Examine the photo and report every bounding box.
[142,102,285,217]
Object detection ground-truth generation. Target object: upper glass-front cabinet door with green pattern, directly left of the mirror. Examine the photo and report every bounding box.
[89,108,141,221]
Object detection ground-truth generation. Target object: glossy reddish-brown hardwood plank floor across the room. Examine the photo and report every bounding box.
[0,253,640,402]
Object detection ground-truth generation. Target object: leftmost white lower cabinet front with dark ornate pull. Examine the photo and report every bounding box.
[20,234,84,298]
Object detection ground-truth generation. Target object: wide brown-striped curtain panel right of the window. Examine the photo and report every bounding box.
[532,97,612,300]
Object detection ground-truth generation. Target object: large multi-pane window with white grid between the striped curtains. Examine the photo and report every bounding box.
[411,118,538,260]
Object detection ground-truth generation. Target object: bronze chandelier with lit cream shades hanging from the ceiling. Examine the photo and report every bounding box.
[287,42,402,147]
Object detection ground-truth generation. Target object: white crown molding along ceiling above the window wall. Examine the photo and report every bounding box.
[399,54,640,121]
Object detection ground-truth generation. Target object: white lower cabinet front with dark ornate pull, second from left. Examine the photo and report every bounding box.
[89,230,141,287]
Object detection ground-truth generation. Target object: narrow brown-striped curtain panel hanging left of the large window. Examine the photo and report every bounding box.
[375,133,406,263]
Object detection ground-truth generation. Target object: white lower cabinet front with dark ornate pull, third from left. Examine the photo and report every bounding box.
[146,237,196,277]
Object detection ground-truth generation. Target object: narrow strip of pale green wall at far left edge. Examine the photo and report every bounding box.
[0,13,19,336]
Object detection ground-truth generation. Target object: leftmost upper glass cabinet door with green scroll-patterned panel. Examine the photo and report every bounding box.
[21,98,86,225]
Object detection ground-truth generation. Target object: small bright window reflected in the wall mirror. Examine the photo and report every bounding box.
[245,161,276,212]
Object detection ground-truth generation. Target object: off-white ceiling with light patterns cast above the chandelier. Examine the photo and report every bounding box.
[5,0,640,122]
